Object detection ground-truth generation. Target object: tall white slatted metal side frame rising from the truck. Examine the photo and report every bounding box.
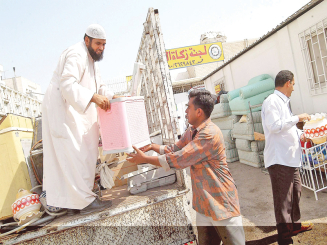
[136,8,178,144]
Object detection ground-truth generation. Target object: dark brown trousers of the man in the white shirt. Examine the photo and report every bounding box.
[268,164,301,233]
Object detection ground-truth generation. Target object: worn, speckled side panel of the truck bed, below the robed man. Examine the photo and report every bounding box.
[3,189,195,245]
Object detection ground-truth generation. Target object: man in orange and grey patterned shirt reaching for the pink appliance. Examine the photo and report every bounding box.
[128,90,245,244]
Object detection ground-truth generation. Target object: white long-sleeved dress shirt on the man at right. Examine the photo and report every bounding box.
[261,90,302,168]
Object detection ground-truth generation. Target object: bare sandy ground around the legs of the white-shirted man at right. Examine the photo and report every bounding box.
[229,162,327,245]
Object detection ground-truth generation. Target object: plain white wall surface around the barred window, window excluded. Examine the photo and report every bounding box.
[205,1,327,114]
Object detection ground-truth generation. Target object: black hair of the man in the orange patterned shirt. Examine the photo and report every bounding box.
[188,89,215,118]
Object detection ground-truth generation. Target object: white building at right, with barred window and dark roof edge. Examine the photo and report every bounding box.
[202,0,327,114]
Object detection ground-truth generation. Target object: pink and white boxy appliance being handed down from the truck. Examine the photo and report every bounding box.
[98,96,151,154]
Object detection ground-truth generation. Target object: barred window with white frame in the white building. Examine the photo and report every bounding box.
[299,18,327,95]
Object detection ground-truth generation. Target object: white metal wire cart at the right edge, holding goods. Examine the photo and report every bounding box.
[300,142,327,200]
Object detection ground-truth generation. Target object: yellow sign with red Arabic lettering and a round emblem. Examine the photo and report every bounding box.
[166,42,224,70]
